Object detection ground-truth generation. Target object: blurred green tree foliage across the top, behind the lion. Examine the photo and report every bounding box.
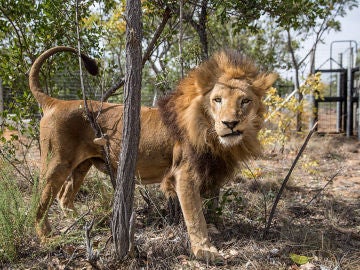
[0,0,357,107]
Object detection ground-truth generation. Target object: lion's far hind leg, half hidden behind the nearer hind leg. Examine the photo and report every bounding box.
[57,159,92,214]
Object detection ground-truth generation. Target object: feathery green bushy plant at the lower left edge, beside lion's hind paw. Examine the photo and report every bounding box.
[0,159,38,261]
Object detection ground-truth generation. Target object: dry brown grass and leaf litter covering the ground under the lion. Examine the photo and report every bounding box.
[0,136,360,270]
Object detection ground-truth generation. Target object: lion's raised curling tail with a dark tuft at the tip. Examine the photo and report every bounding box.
[29,46,99,107]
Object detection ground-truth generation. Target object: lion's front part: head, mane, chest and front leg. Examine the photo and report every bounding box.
[159,50,277,260]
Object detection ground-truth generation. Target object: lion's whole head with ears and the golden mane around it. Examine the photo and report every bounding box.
[159,50,277,153]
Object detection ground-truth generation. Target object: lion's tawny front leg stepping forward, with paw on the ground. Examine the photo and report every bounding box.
[175,167,221,261]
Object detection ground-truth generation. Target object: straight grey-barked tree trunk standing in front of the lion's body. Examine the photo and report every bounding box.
[111,0,142,259]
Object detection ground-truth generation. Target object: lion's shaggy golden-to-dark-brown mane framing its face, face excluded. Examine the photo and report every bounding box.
[158,50,276,193]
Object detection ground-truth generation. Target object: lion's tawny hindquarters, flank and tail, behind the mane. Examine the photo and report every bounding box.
[29,47,174,243]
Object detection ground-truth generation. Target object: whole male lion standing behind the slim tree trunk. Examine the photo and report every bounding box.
[29,47,277,260]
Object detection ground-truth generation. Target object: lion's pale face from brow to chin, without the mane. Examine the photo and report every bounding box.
[209,79,259,147]
